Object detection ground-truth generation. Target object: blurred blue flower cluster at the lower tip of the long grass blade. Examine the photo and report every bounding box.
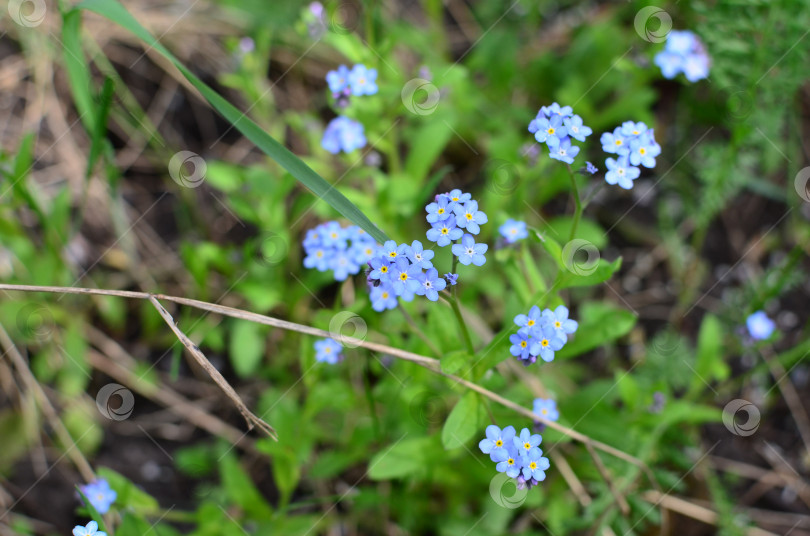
[304,221,378,281]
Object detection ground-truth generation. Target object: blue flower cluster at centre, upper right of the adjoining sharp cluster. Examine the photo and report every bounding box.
[425,189,489,268]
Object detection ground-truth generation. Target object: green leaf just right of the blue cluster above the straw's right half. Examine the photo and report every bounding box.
[556,303,636,359]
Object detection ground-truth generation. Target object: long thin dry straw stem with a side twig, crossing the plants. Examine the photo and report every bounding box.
[0,284,657,478]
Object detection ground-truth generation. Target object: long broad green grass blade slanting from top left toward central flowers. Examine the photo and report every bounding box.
[77,0,388,242]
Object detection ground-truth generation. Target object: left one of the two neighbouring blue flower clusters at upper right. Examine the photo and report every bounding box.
[529,102,593,164]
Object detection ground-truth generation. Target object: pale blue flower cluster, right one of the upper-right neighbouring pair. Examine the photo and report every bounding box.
[599,121,661,190]
